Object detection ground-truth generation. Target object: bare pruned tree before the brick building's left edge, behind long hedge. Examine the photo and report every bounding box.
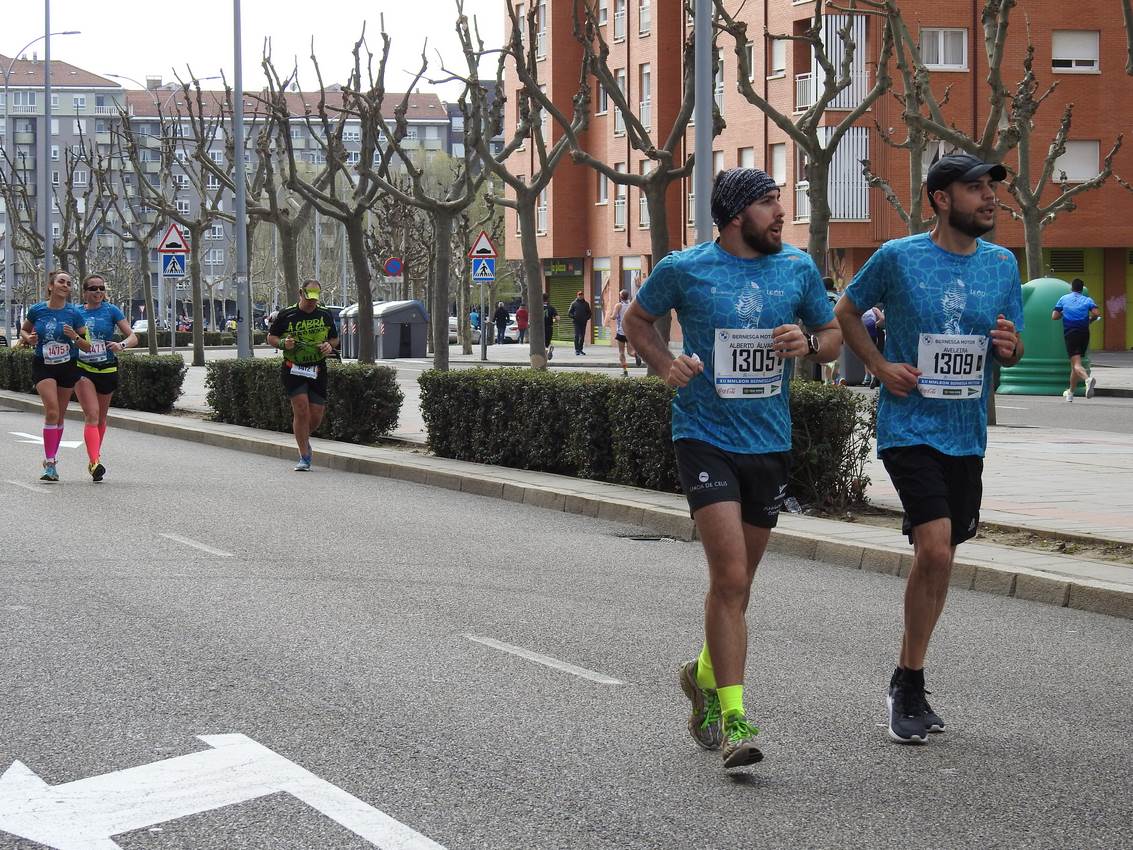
[457,0,590,369]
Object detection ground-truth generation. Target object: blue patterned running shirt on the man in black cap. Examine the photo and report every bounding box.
[845,233,1023,457]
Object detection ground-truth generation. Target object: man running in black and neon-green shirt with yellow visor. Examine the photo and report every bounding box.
[267,280,339,473]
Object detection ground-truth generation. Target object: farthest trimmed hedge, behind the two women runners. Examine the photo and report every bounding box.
[0,348,187,413]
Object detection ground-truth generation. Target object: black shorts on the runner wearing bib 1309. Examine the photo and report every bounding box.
[881,445,983,546]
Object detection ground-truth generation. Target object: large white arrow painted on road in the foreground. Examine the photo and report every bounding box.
[0,734,444,850]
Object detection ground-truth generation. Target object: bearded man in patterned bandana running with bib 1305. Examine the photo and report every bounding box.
[622,169,842,767]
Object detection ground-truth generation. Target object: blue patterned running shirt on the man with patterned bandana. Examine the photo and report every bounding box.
[637,241,834,454]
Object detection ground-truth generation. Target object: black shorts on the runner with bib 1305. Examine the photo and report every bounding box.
[673,440,791,528]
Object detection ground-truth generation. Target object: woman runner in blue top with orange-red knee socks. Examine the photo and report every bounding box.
[75,274,138,481]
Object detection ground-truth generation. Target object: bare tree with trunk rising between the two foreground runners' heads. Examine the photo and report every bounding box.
[715,0,893,273]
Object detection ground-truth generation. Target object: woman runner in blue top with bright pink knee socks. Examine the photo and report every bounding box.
[19,271,91,482]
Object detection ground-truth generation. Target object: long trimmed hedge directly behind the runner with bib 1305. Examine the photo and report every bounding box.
[418,368,876,509]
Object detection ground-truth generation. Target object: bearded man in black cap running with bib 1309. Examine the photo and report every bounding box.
[836,154,1023,743]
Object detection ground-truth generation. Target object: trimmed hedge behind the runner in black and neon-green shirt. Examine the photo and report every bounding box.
[205,357,404,444]
